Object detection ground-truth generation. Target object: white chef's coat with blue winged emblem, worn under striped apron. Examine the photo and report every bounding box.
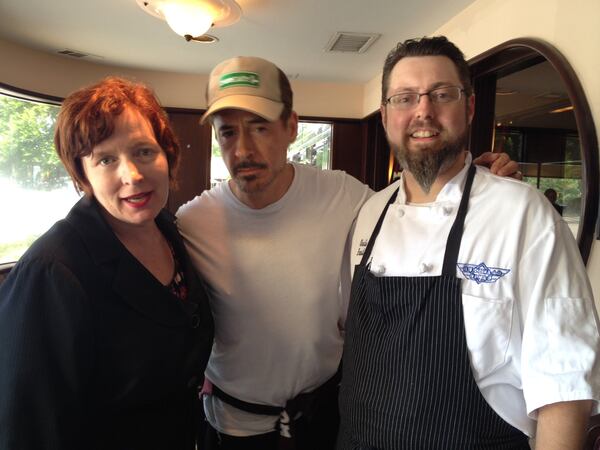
[351,158,600,436]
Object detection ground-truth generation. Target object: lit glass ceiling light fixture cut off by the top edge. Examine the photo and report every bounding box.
[136,0,242,41]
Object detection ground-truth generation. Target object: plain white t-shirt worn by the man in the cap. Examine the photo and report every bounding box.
[177,164,371,436]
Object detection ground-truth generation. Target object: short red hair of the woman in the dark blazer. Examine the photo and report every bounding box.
[54,77,179,195]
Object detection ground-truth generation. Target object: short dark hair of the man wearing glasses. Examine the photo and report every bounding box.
[381,36,473,103]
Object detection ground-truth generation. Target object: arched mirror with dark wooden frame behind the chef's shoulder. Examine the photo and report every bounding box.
[469,39,599,262]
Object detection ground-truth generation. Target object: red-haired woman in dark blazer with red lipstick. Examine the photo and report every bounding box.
[0,77,213,450]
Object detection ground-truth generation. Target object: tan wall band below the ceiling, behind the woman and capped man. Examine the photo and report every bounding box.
[0,40,363,118]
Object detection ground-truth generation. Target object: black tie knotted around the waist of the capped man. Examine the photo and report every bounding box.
[212,364,342,449]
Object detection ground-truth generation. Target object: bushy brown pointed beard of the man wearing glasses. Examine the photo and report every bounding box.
[389,123,469,194]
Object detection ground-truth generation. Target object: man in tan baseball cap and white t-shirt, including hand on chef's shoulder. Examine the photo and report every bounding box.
[177,57,516,450]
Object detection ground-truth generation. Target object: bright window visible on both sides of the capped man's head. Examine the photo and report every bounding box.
[210,122,333,187]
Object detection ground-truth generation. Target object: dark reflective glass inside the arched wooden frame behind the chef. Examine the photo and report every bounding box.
[494,62,583,236]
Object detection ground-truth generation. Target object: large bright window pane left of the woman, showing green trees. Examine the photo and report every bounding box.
[0,94,78,263]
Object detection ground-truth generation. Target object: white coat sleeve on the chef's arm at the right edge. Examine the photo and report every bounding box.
[518,220,600,418]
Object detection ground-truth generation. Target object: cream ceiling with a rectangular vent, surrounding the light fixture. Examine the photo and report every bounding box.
[0,0,473,82]
